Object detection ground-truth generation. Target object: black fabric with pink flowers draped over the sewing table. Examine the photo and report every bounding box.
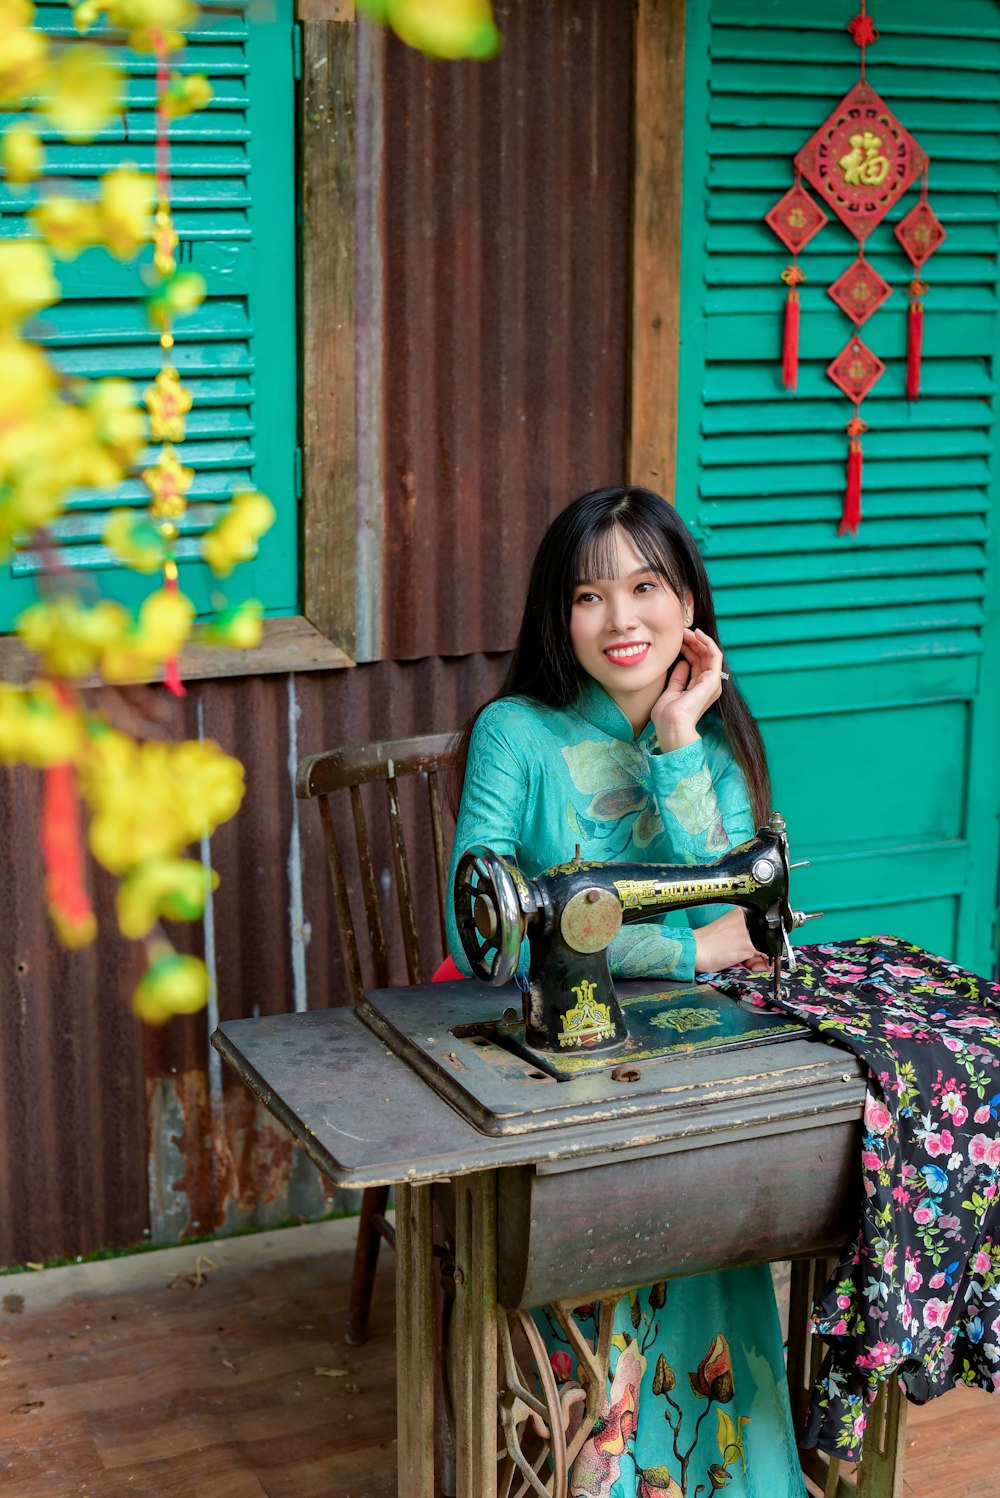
[714,936,1000,1461]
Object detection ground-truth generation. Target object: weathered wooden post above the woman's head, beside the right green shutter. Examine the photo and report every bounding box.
[626,0,684,503]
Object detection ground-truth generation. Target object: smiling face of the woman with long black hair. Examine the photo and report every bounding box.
[569,526,692,733]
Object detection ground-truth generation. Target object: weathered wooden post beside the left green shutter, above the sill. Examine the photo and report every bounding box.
[300,10,358,658]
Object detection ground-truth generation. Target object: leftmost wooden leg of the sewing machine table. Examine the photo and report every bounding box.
[395,1186,434,1498]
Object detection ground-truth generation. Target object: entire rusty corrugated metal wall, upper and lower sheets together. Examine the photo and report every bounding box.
[0,0,632,1264]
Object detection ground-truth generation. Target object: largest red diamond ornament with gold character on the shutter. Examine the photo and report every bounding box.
[795,82,927,240]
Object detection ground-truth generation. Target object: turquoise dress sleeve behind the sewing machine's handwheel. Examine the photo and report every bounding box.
[445,706,528,974]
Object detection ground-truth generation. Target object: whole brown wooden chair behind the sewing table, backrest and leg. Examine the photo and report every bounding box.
[295,734,455,1345]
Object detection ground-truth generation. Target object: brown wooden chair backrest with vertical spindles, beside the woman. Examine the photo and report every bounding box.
[295,734,455,1002]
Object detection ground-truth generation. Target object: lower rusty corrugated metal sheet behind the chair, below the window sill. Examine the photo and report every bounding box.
[0,656,506,1264]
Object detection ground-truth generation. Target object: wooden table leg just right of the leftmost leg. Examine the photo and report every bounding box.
[449,1170,497,1498]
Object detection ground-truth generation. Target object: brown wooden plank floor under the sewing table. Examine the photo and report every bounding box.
[0,1225,1000,1498]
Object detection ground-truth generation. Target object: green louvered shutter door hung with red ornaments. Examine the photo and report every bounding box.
[678,0,1000,971]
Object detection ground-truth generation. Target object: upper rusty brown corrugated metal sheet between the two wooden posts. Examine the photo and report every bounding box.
[382,0,632,661]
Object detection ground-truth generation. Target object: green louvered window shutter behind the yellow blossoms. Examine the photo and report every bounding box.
[0,0,298,629]
